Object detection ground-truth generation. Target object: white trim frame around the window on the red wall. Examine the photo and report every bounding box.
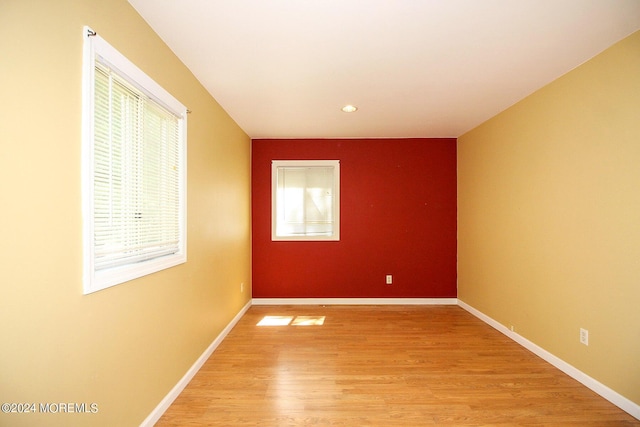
[271,160,340,241]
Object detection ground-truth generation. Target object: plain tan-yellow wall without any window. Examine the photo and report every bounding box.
[458,32,640,404]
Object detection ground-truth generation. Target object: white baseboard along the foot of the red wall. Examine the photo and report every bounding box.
[252,298,458,305]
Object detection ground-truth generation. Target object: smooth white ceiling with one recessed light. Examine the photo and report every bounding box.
[129,0,640,138]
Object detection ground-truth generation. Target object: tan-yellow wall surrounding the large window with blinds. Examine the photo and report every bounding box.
[0,0,251,426]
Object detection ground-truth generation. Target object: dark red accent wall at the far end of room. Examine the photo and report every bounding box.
[251,138,457,298]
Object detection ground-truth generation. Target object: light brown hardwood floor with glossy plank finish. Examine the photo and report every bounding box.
[156,306,640,427]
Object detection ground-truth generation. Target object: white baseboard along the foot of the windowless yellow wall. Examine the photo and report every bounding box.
[458,300,640,420]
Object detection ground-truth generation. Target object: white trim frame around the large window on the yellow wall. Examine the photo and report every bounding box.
[82,27,187,294]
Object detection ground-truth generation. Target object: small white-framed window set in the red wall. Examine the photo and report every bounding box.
[271,160,340,240]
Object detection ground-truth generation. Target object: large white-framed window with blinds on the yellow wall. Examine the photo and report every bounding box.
[82,27,187,294]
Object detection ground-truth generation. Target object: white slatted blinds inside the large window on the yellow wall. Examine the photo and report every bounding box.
[94,62,180,270]
